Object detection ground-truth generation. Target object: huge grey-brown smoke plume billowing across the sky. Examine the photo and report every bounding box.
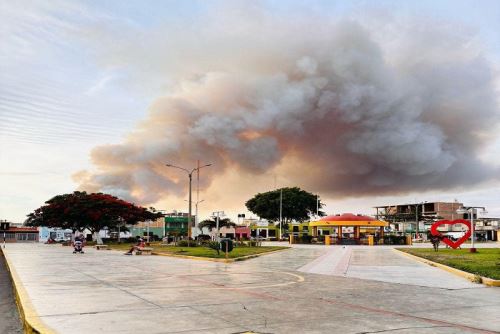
[75,9,499,203]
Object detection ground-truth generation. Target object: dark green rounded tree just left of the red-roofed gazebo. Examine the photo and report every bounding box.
[245,187,325,225]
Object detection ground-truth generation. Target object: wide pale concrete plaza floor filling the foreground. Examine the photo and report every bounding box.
[5,244,500,334]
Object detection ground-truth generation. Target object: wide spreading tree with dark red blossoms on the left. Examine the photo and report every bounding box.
[26,191,162,233]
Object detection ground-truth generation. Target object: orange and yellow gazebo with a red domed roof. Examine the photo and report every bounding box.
[309,213,389,244]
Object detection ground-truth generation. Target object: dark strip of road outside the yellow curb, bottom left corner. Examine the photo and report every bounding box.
[0,250,23,334]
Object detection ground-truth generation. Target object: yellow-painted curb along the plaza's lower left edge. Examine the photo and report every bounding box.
[0,250,55,334]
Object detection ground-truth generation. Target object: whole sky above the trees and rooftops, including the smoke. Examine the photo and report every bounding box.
[0,0,500,222]
